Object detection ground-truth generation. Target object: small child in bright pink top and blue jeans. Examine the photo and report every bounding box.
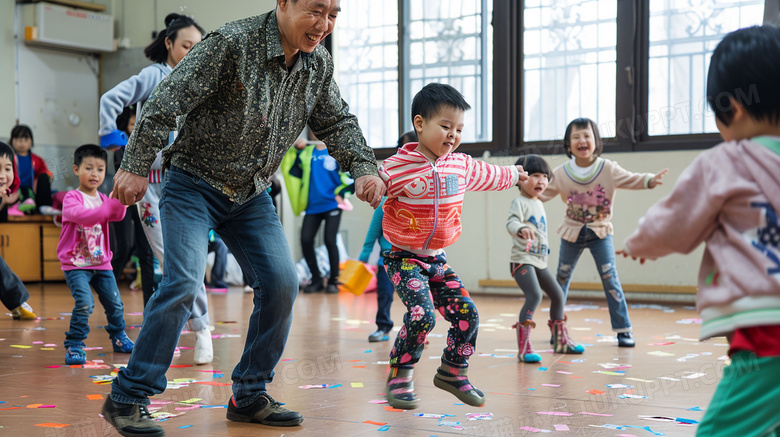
[57,144,133,364]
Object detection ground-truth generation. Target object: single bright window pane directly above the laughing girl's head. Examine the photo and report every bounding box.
[523,0,617,141]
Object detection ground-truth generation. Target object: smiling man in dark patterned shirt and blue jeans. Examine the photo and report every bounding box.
[102,0,385,437]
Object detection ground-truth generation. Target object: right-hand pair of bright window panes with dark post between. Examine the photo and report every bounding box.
[516,0,765,152]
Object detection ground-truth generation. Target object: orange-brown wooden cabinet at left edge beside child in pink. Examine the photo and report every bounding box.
[0,216,65,282]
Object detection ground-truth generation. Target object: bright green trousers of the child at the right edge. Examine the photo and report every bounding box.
[696,351,780,437]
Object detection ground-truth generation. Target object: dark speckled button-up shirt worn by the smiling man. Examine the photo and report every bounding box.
[121,11,378,204]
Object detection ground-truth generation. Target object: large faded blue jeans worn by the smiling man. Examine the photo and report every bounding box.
[111,167,298,407]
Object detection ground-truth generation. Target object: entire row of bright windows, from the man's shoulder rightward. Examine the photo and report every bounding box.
[334,0,768,157]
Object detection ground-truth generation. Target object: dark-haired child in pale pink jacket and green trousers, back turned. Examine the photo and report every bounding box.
[624,25,780,437]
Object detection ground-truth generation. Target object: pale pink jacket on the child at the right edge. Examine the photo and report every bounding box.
[625,137,780,339]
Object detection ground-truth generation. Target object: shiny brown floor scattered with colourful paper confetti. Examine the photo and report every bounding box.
[0,283,727,437]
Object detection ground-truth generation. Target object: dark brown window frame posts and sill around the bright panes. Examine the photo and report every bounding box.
[364,0,780,159]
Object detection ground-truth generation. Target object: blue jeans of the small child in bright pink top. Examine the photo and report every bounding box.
[64,269,125,348]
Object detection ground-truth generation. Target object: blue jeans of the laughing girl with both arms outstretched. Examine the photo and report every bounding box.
[558,226,631,332]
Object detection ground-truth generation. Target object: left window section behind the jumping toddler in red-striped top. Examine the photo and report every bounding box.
[336,0,493,148]
